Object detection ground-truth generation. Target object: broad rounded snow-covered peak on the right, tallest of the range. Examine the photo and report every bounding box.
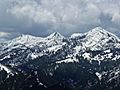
[84,27,120,50]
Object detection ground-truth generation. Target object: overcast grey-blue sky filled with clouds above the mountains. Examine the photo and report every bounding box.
[0,0,120,41]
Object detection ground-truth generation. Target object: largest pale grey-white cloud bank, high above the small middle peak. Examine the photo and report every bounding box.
[10,0,100,33]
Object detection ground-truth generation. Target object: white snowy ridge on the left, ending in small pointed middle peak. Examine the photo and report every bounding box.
[5,32,64,47]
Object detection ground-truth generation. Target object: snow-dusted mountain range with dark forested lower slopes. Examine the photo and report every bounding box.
[0,27,120,90]
